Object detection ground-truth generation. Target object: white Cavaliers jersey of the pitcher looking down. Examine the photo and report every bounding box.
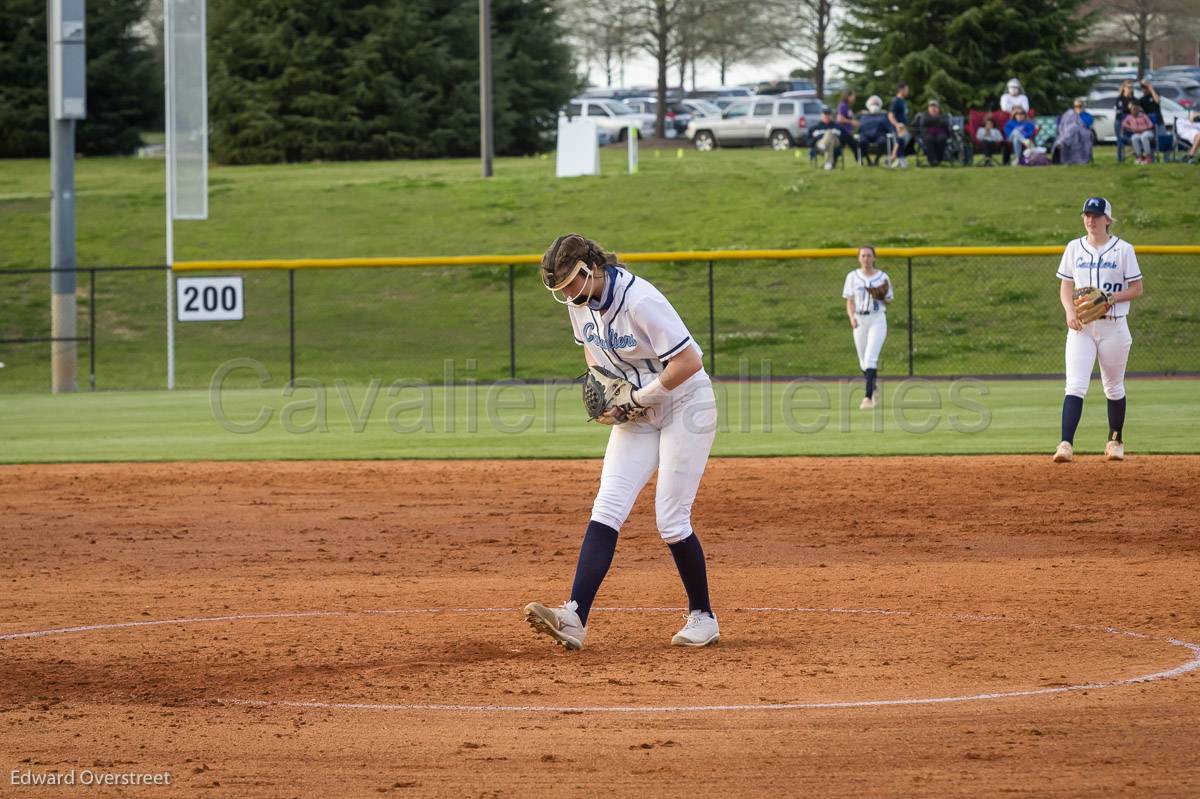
[568,266,703,388]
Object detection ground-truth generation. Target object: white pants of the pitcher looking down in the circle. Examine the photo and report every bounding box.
[592,371,716,543]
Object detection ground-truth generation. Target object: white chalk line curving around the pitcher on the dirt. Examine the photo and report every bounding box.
[0,607,1200,714]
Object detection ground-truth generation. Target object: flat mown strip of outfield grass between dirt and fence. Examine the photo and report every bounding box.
[0,379,1200,463]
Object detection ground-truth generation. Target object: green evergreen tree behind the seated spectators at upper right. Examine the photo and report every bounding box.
[842,0,1093,114]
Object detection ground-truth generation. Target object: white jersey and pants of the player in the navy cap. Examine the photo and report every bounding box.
[1056,236,1141,400]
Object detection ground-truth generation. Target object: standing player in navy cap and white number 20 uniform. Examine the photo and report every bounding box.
[1054,197,1142,463]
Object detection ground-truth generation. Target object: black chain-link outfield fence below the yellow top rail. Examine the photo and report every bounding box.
[0,254,1200,391]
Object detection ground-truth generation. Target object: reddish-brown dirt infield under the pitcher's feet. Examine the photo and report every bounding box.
[0,456,1200,799]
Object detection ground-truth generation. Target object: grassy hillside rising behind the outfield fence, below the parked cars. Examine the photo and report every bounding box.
[0,145,1200,394]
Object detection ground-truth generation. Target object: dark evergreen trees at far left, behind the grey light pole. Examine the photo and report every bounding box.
[0,0,162,158]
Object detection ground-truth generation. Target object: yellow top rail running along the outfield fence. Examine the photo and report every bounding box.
[173,245,1200,272]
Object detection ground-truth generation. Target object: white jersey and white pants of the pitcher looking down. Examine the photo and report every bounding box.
[568,266,716,543]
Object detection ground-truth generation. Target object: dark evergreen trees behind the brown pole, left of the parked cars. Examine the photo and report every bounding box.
[209,0,577,163]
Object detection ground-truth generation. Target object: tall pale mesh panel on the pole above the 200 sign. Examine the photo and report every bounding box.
[163,0,209,220]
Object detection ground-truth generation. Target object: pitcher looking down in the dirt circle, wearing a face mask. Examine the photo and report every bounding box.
[524,234,720,649]
